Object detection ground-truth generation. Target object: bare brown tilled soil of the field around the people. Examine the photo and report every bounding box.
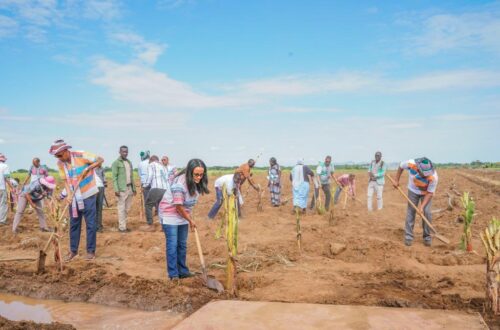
[0,169,500,329]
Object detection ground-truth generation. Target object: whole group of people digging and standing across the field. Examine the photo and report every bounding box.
[0,140,438,279]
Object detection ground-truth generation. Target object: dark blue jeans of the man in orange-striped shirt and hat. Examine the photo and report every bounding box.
[69,194,97,253]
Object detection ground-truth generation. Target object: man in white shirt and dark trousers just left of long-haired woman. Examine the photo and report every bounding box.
[145,155,169,225]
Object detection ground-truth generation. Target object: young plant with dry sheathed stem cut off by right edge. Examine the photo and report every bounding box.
[480,218,500,315]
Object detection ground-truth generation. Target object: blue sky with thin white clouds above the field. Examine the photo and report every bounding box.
[0,0,500,169]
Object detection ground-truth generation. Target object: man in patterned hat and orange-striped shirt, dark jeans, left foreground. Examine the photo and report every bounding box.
[49,140,104,262]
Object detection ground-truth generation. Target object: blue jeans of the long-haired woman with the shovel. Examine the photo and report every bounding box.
[162,225,189,278]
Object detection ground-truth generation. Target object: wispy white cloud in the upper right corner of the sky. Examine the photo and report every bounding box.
[411,4,500,55]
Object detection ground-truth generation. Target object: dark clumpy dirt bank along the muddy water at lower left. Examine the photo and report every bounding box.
[0,261,224,313]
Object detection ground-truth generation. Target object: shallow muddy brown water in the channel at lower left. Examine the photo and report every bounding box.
[0,294,184,329]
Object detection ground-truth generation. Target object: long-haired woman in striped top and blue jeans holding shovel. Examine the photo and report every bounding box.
[160,159,209,280]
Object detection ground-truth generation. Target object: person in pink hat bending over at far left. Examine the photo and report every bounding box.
[12,176,56,234]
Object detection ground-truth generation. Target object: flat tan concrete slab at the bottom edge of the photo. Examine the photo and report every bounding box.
[174,300,488,330]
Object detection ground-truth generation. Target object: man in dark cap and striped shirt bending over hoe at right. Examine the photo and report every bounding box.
[394,157,439,246]
